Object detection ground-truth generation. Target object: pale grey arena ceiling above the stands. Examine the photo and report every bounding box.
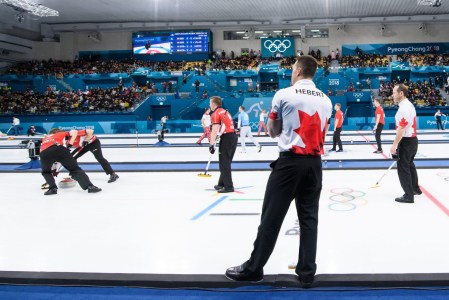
[0,0,449,39]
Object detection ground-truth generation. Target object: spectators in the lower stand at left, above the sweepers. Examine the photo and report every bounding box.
[0,87,141,114]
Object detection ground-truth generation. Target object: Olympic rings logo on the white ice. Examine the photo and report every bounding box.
[328,188,368,212]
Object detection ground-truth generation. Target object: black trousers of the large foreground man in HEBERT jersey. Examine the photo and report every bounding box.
[245,156,322,281]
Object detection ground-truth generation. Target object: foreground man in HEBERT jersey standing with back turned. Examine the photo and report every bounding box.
[225,55,332,287]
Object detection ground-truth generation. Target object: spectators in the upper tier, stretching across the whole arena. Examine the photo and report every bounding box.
[5,49,449,77]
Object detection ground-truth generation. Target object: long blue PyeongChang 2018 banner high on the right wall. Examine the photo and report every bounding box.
[341,43,449,55]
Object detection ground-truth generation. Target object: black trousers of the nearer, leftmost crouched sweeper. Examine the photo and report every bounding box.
[40,146,92,190]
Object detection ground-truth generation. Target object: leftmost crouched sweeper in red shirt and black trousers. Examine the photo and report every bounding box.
[40,128,101,195]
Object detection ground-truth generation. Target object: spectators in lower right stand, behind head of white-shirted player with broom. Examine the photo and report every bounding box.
[379,78,447,106]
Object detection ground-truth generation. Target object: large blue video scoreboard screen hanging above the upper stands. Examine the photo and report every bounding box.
[133,30,210,54]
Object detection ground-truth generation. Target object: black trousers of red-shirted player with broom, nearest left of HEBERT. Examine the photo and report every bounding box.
[218,133,238,188]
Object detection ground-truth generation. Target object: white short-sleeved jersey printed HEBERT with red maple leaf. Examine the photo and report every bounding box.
[269,79,332,156]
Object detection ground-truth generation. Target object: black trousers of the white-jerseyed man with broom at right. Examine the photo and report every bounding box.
[398,137,419,199]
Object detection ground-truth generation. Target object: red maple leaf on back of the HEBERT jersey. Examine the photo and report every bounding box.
[292,110,324,155]
